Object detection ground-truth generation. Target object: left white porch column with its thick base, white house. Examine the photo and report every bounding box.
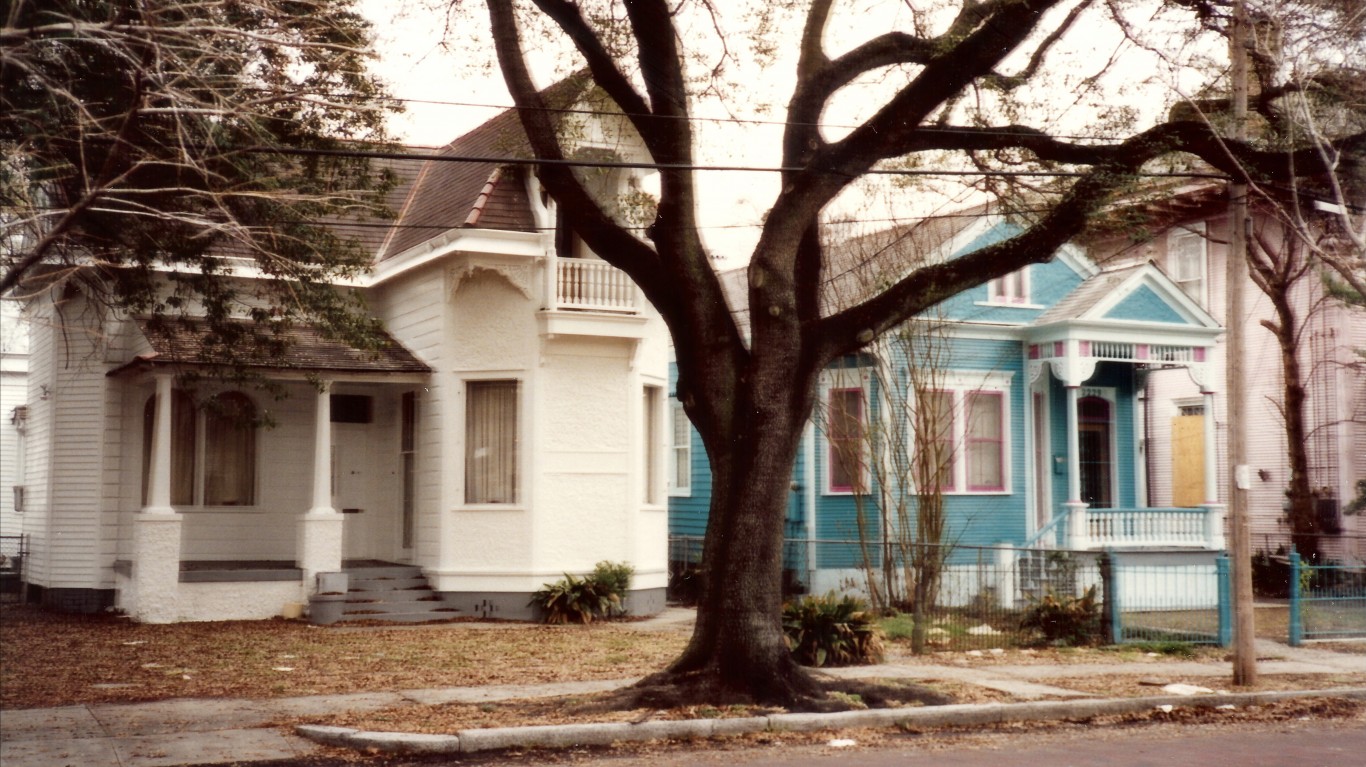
[132,373,182,623]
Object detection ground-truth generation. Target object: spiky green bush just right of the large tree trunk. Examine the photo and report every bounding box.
[783,592,882,666]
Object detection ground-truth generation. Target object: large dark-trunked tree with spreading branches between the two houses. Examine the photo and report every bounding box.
[488,0,1366,705]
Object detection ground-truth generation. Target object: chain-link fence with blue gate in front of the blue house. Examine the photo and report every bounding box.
[669,536,1232,649]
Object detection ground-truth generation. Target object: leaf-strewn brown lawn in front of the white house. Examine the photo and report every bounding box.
[0,606,687,708]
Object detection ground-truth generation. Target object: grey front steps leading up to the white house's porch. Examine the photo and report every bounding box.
[331,563,460,623]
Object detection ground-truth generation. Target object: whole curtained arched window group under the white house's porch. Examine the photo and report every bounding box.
[142,390,257,506]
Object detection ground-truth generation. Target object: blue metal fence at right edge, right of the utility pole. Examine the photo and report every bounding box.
[1290,552,1366,647]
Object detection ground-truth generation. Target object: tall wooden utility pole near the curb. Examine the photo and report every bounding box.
[1224,0,1257,686]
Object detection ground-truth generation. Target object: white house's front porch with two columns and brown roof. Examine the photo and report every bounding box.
[111,317,428,622]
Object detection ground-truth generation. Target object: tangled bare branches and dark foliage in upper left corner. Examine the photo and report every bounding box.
[0,0,388,355]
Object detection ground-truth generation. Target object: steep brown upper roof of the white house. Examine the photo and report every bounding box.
[376,75,590,261]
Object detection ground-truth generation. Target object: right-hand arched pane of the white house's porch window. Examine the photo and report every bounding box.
[204,391,255,506]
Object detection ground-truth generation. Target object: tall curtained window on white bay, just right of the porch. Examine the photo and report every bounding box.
[464,380,519,503]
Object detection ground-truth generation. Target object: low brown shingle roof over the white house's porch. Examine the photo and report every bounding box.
[109,319,432,375]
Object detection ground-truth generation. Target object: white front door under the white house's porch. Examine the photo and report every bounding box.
[332,422,392,559]
